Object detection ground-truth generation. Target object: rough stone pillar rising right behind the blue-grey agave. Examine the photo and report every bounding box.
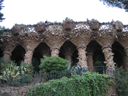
[77,46,88,68]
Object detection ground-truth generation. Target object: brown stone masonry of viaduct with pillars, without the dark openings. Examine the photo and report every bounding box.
[0,20,128,74]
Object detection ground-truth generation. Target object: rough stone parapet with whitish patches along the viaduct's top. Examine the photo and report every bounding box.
[1,22,128,36]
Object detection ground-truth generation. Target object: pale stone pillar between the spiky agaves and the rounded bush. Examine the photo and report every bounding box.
[24,46,34,64]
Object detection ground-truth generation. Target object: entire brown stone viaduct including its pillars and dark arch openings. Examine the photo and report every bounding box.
[0,20,128,74]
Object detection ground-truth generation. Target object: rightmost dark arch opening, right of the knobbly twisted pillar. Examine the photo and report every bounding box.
[112,41,126,67]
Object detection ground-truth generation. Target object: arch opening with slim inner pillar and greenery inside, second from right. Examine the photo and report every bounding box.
[87,40,105,71]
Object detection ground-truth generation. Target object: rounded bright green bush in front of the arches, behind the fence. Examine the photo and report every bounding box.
[39,56,68,73]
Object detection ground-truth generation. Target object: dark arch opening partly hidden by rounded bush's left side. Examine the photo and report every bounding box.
[32,42,51,72]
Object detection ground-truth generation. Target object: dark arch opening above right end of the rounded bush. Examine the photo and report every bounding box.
[59,41,78,66]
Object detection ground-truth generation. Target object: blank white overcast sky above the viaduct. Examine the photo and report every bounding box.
[0,0,128,28]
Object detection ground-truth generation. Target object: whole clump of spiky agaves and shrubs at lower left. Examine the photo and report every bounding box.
[0,59,33,86]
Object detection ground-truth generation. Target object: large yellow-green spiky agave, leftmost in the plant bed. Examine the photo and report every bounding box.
[2,62,20,82]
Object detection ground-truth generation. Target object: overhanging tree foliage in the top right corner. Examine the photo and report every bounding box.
[100,0,128,12]
